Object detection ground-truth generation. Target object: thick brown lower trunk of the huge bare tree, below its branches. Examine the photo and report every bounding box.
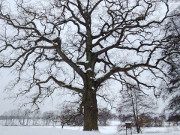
[83,91,98,131]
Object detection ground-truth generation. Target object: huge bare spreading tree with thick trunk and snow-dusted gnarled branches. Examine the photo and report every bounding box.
[0,0,174,130]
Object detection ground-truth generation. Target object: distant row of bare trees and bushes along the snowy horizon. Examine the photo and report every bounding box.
[0,104,180,131]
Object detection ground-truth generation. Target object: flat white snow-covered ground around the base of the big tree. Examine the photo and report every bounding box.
[0,126,180,135]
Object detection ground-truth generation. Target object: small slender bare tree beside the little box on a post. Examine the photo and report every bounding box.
[118,85,155,133]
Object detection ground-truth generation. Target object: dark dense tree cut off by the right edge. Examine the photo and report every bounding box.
[163,6,180,116]
